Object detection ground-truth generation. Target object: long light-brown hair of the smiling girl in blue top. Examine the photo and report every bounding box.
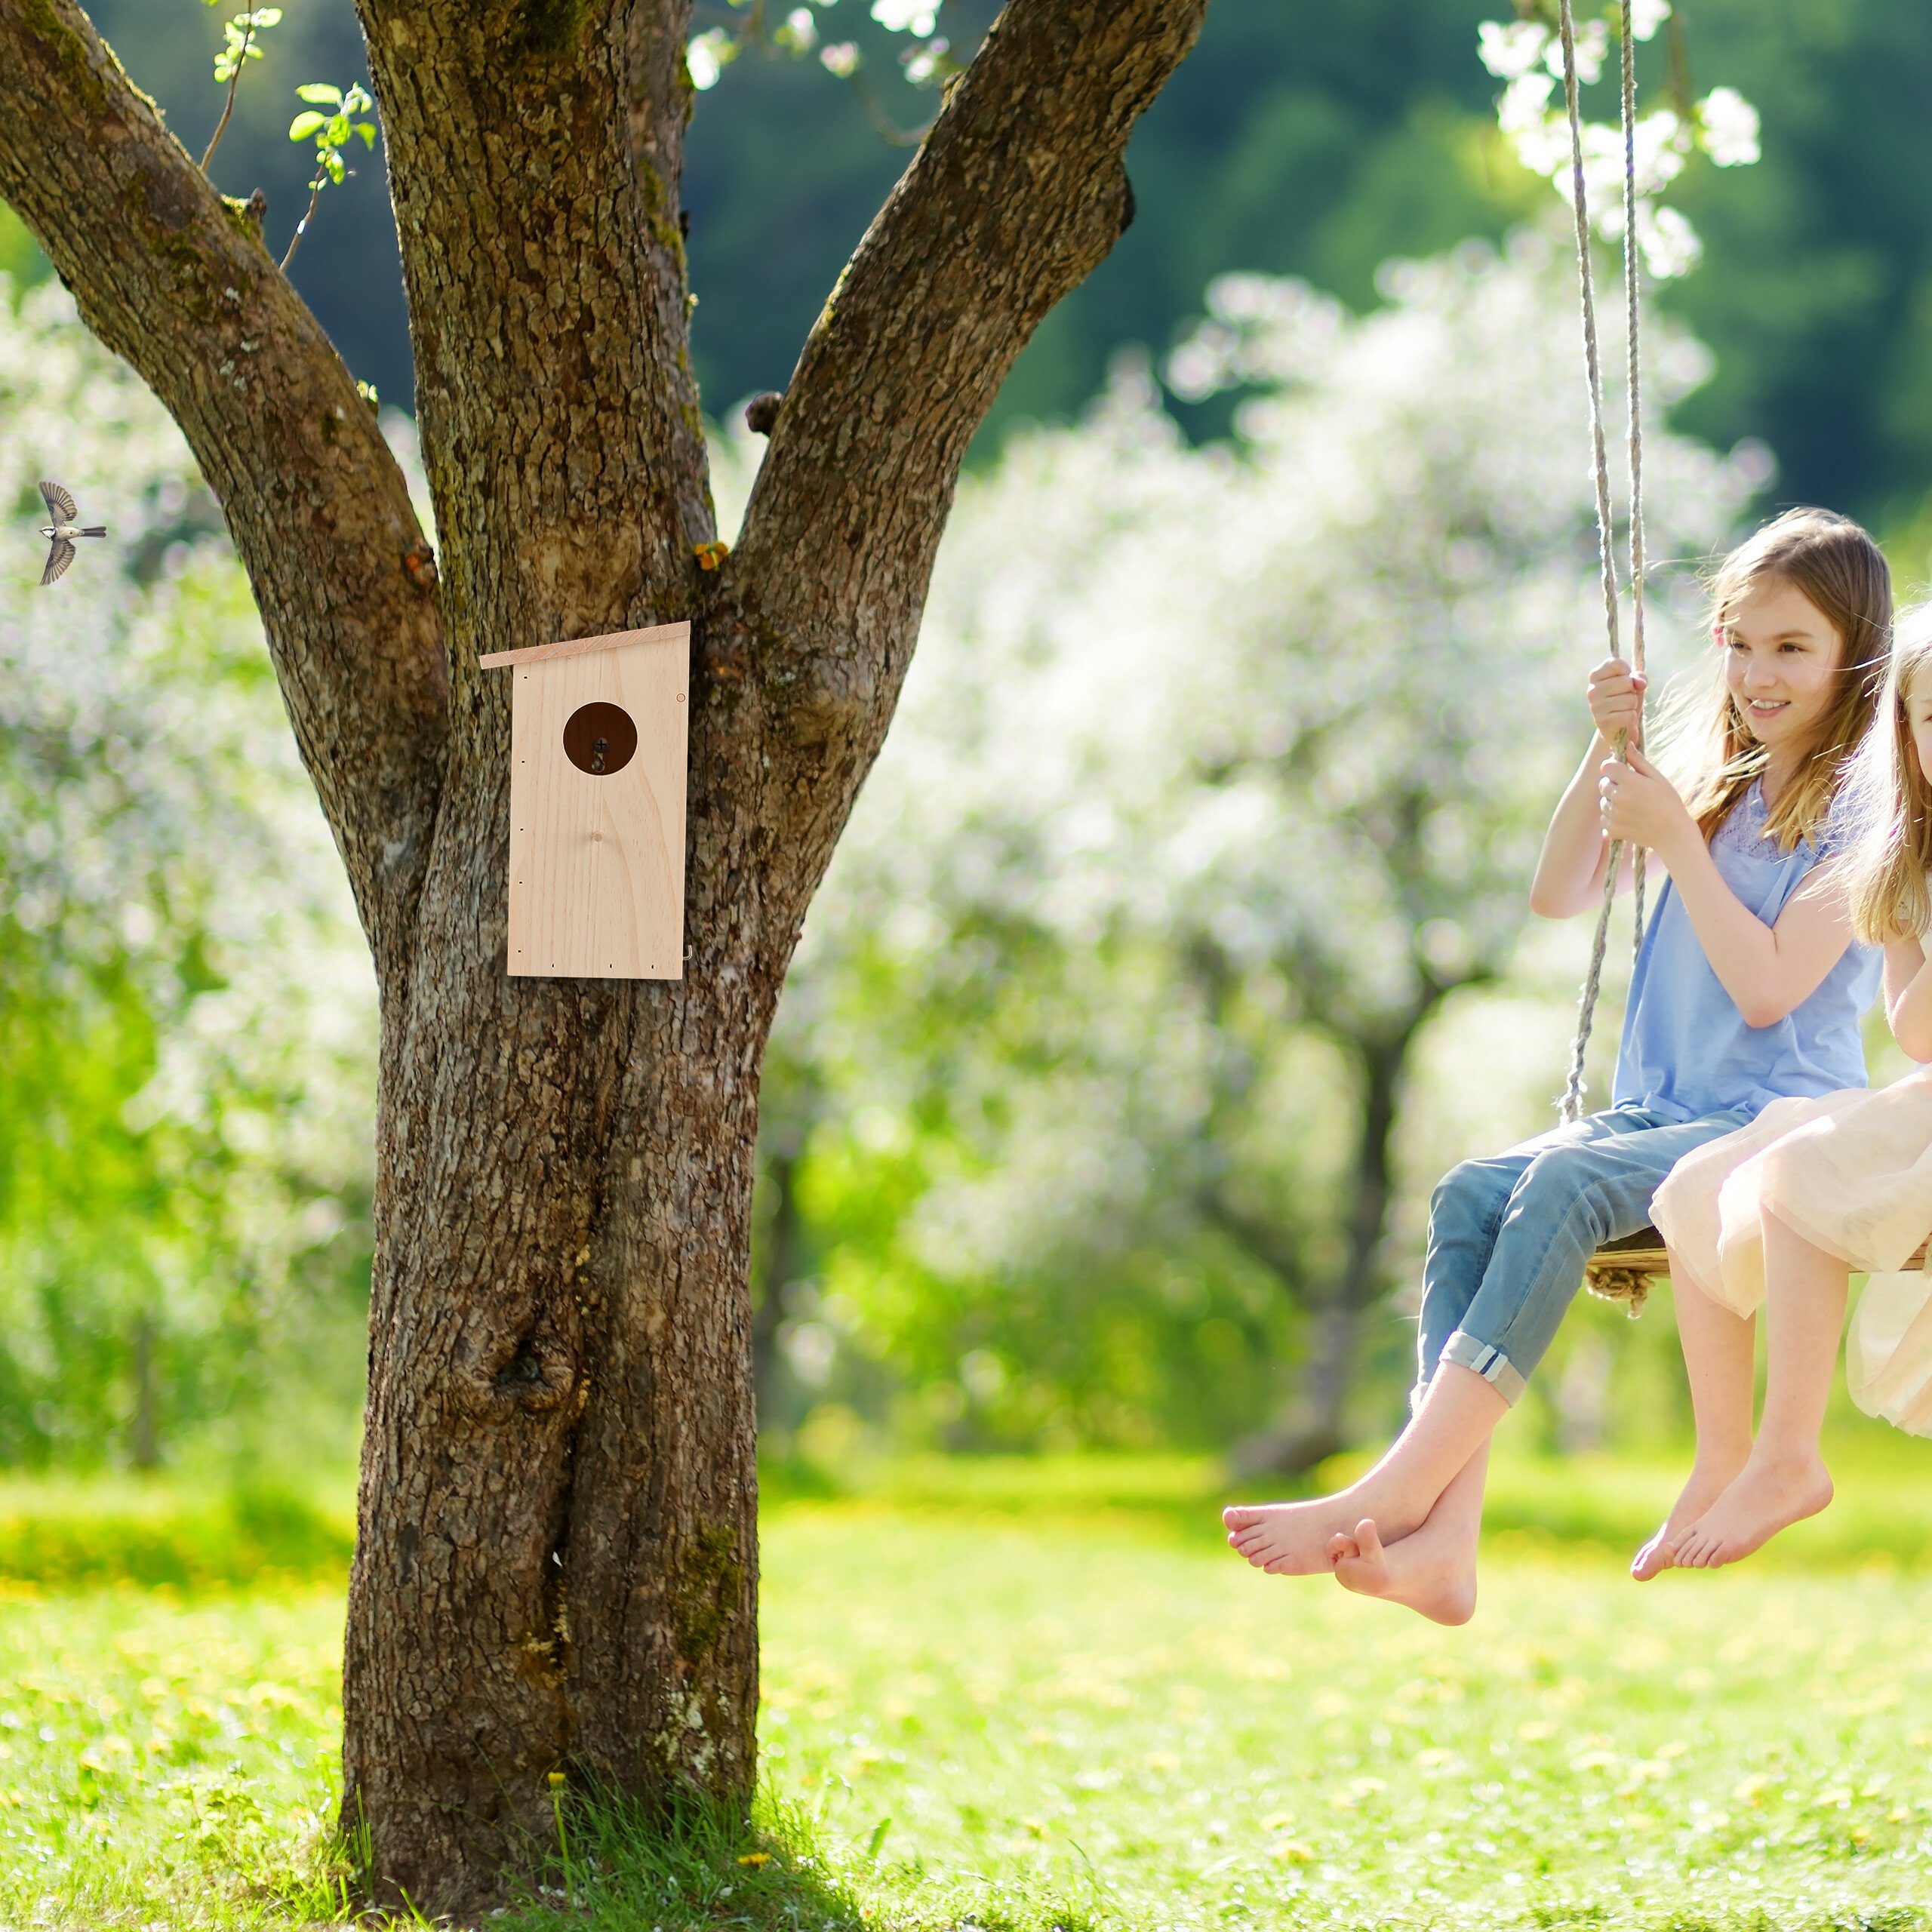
[1663,510,1891,852]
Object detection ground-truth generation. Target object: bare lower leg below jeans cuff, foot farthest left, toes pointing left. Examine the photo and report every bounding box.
[1221,1362,1509,1577]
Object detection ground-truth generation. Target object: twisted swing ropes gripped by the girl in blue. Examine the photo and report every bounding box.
[1557,0,1644,1121]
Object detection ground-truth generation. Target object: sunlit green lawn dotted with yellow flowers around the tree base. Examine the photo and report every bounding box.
[0,1459,1932,1932]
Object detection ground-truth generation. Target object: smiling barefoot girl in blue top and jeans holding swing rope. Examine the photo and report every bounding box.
[1223,510,1891,1623]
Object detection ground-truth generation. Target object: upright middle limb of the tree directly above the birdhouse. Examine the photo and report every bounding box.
[358,0,713,668]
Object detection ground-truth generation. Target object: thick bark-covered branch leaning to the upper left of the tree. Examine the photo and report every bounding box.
[0,0,448,974]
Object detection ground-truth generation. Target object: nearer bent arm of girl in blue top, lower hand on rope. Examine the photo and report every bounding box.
[1601,752,1850,1026]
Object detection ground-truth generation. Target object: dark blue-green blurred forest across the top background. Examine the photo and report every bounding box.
[0,0,1932,529]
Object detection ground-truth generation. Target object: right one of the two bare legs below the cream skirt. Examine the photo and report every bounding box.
[1677,1211,1850,1569]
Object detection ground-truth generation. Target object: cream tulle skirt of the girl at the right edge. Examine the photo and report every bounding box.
[1650,1069,1932,1435]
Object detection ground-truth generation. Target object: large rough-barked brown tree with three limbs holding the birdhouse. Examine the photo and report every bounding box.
[0,0,1205,1915]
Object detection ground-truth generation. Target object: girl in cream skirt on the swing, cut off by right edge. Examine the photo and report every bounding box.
[1635,607,1932,1579]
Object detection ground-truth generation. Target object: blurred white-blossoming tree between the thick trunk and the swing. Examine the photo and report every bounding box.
[749,235,1764,1466]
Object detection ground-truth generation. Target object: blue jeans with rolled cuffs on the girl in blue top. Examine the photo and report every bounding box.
[1414,1107,1750,1403]
